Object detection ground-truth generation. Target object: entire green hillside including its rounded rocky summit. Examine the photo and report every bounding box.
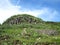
[0,14,60,45]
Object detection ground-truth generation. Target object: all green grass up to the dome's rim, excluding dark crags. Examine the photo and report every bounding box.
[0,15,60,45]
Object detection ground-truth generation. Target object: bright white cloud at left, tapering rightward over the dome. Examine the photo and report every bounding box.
[0,0,41,23]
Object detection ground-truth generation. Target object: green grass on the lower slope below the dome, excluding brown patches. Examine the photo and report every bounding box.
[1,24,60,45]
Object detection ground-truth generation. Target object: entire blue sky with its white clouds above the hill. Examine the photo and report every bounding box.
[0,0,60,23]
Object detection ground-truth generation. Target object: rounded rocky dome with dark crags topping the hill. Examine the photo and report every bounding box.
[3,14,42,24]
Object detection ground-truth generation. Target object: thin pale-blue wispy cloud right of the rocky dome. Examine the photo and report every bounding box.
[38,8,59,21]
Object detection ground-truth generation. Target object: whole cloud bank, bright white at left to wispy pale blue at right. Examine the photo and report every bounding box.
[0,0,58,23]
